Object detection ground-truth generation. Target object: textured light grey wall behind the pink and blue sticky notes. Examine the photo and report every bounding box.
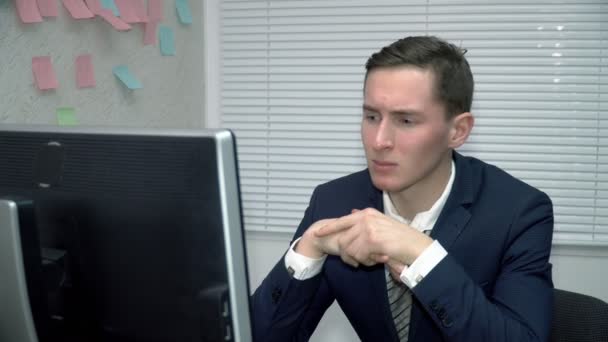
[0,0,205,128]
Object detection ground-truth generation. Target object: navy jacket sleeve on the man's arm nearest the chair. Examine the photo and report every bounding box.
[413,192,553,342]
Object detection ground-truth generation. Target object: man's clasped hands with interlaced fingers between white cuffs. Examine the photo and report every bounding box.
[296,208,433,279]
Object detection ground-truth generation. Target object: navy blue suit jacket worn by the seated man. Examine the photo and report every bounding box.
[252,153,553,342]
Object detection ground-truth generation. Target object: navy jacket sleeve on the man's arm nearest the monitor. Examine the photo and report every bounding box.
[251,190,334,342]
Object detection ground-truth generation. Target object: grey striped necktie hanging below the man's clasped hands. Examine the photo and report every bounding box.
[386,272,412,342]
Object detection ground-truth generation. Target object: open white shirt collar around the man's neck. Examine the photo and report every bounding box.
[382,160,456,232]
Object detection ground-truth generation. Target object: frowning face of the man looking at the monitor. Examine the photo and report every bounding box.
[361,67,451,193]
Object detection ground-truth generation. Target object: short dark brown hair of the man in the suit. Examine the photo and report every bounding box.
[365,36,474,118]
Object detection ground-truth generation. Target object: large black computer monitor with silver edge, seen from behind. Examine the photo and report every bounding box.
[0,125,252,342]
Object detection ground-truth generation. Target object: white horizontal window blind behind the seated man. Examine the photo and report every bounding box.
[220,0,608,242]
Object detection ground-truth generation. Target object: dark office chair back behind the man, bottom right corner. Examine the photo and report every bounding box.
[550,289,608,342]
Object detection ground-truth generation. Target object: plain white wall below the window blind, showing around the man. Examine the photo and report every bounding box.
[247,231,608,342]
